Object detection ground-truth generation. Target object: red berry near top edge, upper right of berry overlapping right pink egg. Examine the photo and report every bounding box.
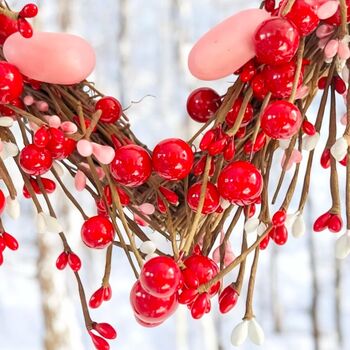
[286,0,320,36]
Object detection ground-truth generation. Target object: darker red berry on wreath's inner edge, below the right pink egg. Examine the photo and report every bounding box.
[187,87,221,123]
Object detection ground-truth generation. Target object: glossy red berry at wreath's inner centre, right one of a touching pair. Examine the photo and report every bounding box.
[152,139,193,181]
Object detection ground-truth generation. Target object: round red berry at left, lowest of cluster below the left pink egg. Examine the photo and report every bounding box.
[19,145,52,175]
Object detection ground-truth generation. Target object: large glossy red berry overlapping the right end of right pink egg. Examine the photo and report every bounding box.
[254,17,300,65]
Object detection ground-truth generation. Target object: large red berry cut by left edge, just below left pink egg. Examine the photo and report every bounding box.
[0,61,23,103]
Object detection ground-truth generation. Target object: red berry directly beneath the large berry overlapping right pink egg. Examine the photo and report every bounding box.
[262,61,303,98]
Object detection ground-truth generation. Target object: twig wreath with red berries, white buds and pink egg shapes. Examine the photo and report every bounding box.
[0,0,350,349]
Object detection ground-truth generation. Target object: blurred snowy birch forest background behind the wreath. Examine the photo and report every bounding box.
[0,0,350,350]
